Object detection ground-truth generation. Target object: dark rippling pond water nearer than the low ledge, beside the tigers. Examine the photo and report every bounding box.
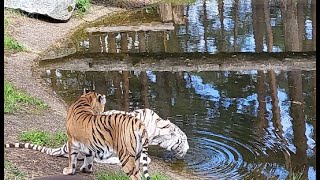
[43,69,316,179]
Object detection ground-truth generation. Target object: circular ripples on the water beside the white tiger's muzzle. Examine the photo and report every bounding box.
[176,131,288,179]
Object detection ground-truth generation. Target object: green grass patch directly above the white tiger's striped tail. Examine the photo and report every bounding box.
[19,129,67,147]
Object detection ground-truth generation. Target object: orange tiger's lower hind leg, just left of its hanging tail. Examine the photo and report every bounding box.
[120,155,142,180]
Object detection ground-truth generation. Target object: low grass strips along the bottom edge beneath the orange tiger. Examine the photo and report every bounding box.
[95,171,169,180]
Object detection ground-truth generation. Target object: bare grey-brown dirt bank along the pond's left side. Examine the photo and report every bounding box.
[4,4,195,179]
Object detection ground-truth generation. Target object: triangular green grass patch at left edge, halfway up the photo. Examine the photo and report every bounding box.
[4,81,48,113]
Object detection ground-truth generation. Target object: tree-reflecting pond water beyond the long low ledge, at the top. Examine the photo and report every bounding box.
[72,0,316,53]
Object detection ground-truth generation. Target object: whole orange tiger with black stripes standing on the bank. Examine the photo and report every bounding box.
[63,91,150,180]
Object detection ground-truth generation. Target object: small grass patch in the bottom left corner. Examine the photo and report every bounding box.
[4,161,26,180]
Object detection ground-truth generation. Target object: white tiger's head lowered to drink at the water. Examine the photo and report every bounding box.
[152,120,189,159]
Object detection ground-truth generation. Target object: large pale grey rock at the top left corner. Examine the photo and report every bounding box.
[4,0,76,21]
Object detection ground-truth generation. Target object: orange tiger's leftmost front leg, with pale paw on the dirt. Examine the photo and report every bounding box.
[63,138,79,175]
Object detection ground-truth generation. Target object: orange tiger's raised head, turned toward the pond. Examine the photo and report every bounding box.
[82,89,107,114]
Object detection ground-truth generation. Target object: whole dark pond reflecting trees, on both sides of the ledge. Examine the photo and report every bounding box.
[40,0,316,179]
